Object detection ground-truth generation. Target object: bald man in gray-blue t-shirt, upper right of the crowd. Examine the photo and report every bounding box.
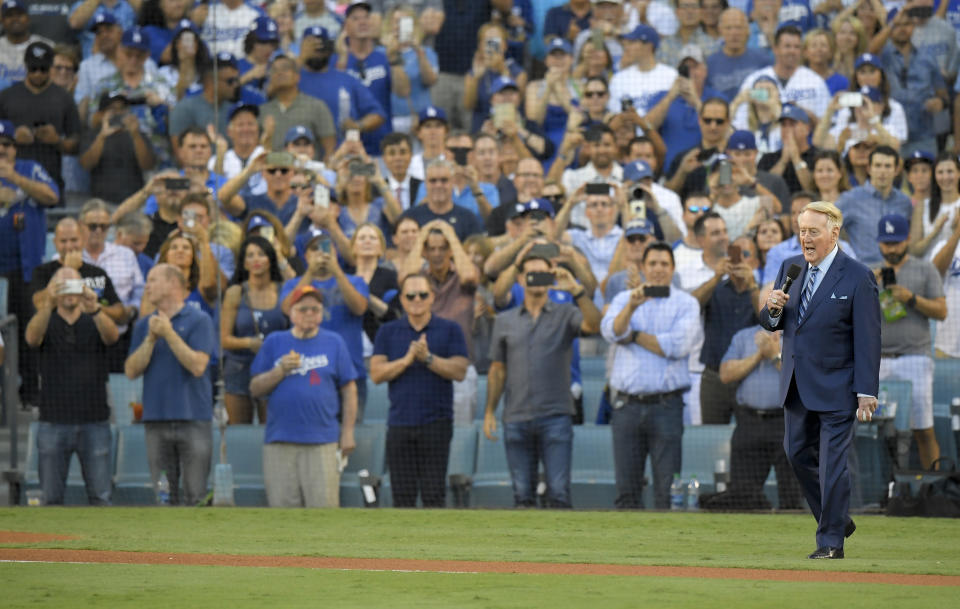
[707,8,773,100]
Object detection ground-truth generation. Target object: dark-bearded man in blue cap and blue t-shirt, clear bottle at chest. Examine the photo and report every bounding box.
[300,25,387,142]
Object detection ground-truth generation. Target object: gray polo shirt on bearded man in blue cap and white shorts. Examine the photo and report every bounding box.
[880,256,943,355]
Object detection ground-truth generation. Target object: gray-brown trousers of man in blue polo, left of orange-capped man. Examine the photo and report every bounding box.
[144,421,213,505]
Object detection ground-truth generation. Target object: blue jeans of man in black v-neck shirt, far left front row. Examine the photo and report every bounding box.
[37,421,112,505]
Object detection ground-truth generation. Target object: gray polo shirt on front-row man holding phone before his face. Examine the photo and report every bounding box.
[490,302,583,423]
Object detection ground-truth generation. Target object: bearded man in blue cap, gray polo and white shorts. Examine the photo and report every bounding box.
[874,214,947,469]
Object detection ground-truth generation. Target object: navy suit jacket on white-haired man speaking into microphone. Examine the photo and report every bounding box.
[760,250,880,412]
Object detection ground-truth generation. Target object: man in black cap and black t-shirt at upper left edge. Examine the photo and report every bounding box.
[0,42,80,192]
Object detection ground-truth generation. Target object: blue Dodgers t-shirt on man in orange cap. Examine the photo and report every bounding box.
[250,328,357,444]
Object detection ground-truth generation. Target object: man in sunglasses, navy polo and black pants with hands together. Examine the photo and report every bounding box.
[370,274,470,508]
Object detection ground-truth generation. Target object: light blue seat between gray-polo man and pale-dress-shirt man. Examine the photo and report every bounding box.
[570,425,617,510]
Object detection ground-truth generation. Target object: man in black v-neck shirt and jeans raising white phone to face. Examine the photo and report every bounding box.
[24,266,119,505]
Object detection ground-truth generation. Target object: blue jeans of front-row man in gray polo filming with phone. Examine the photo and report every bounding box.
[503,414,573,508]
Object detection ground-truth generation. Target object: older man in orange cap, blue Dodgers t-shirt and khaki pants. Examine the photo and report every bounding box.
[250,285,357,507]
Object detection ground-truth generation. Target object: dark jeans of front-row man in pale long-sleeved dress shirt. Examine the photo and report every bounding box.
[610,394,683,510]
